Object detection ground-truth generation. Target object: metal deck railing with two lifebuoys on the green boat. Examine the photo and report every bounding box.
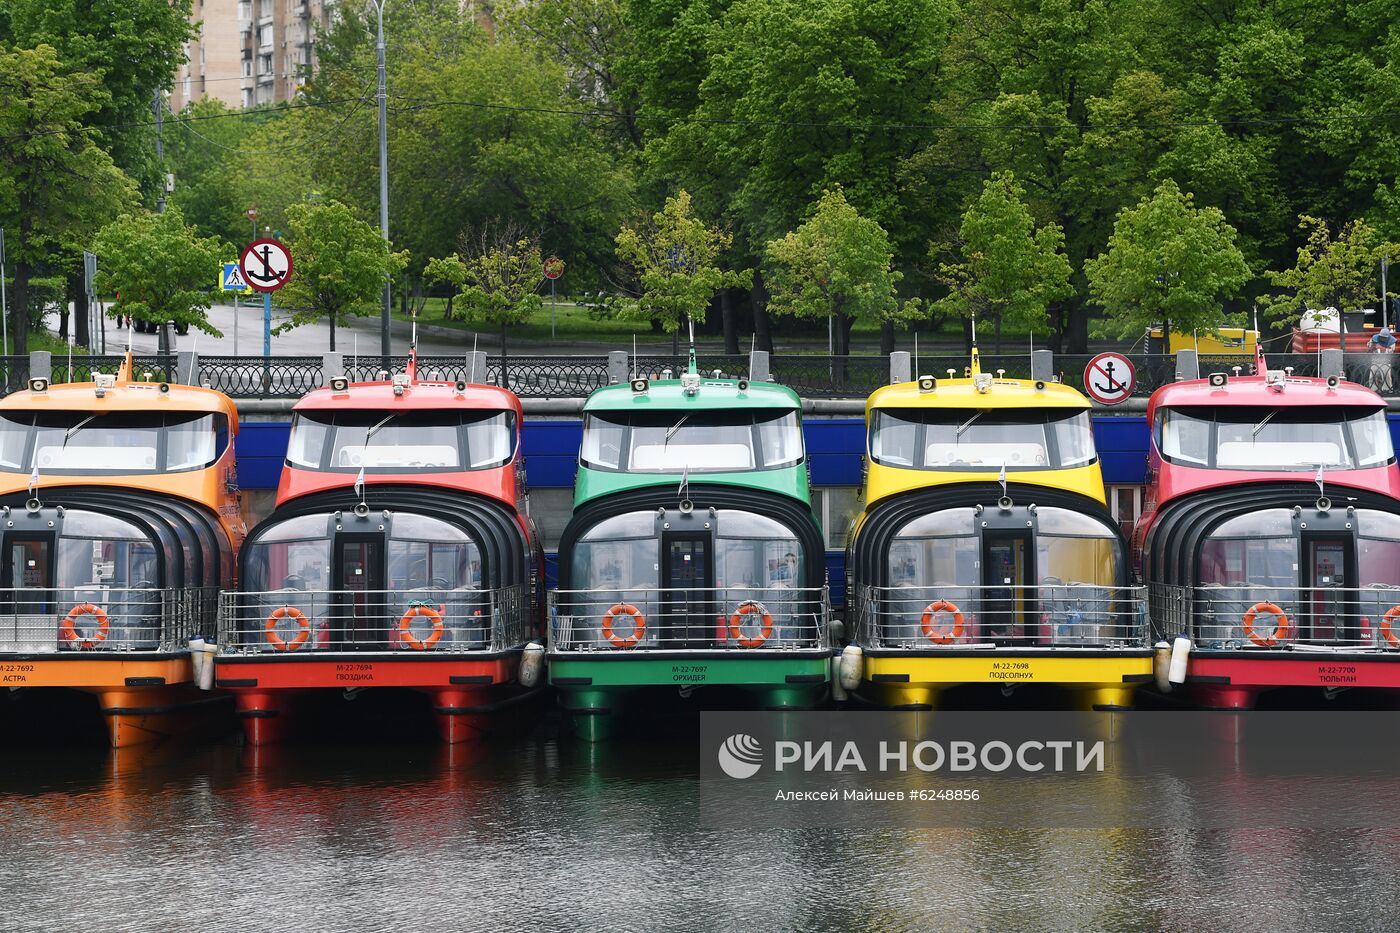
[549,584,830,654]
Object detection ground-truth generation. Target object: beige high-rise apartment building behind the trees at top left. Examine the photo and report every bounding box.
[171,0,336,112]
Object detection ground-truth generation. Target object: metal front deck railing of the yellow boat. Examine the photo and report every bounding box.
[848,583,1148,650]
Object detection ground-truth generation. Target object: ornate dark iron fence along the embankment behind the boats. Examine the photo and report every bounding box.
[0,344,1400,398]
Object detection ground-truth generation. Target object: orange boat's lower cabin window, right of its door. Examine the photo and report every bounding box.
[55,510,158,590]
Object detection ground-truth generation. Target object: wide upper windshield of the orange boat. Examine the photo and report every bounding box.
[0,410,228,475]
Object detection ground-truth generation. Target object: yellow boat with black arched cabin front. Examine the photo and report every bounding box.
[847,347,1152,709]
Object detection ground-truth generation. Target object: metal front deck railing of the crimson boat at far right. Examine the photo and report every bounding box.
[1148,583,1400,651]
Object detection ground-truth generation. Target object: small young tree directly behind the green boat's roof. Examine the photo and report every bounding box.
[617,191,753,333]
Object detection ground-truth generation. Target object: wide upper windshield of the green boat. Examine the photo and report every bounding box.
[580,409,804,474]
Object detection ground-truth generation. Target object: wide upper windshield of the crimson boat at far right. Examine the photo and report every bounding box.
[1156,405,1394,472]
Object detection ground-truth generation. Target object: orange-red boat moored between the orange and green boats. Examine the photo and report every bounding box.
[217,356,543,745]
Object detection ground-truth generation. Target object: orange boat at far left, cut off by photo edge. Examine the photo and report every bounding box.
[0,354,245,747]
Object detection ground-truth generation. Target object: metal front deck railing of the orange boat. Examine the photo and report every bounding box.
[0,584,217,656]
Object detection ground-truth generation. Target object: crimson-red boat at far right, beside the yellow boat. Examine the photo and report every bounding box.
[1134,348,1400,709]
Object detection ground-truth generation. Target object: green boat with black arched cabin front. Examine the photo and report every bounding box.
[549,350,832,740]
